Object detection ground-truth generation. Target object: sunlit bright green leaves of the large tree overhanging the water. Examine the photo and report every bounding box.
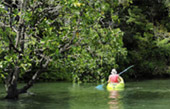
[0,0,127,82]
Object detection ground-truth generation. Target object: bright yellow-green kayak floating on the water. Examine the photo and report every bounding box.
[106,77,125,91]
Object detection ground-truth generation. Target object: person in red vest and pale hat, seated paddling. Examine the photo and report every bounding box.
[108,69,121,83]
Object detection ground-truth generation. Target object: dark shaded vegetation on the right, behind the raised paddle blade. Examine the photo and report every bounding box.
[119,0,170,79]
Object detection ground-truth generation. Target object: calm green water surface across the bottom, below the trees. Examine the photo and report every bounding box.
[0,80,170,109]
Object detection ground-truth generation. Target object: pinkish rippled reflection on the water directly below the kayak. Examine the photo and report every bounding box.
[108,90,124,109]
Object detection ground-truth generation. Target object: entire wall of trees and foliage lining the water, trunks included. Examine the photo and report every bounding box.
[0,0,170,98]
